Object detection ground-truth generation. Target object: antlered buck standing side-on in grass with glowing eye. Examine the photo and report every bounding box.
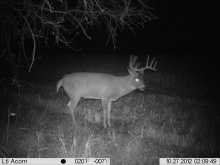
[57,55,157,128]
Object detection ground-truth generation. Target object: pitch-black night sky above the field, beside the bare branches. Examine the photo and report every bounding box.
[75,0,220,54]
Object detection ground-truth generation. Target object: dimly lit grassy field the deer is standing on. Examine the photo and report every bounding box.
[0,55,219,165]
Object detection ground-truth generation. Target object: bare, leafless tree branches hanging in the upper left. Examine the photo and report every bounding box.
[0,0,156,86]
